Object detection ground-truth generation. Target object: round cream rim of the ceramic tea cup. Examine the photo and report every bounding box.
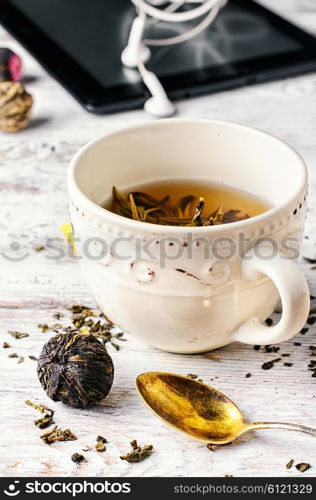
[67,118,308,235]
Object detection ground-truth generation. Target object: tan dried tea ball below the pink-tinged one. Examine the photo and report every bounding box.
[0,82,33,132]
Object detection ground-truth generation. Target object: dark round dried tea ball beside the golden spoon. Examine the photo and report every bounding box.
[37,333,114,408]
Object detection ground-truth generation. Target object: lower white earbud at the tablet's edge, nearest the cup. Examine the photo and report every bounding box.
[142,70,176,118]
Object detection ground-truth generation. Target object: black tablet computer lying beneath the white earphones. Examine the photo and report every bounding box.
[0,0,316,113]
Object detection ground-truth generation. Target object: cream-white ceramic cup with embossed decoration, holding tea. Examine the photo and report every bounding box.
[68,119,309,353]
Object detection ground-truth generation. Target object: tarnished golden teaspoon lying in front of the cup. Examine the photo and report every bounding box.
[136,372,316,444]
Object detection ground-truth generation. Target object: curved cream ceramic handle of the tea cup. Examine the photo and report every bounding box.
[233,245,310,345]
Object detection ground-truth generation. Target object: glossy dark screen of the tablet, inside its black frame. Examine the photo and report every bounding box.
[11,0,302,87]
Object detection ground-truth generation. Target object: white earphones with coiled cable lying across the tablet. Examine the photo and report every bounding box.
[121,0,227,118]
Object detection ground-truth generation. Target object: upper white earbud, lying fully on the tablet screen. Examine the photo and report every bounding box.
[121,15,150,68]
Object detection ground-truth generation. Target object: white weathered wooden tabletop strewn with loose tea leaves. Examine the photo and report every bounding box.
[0,0,316,477]
